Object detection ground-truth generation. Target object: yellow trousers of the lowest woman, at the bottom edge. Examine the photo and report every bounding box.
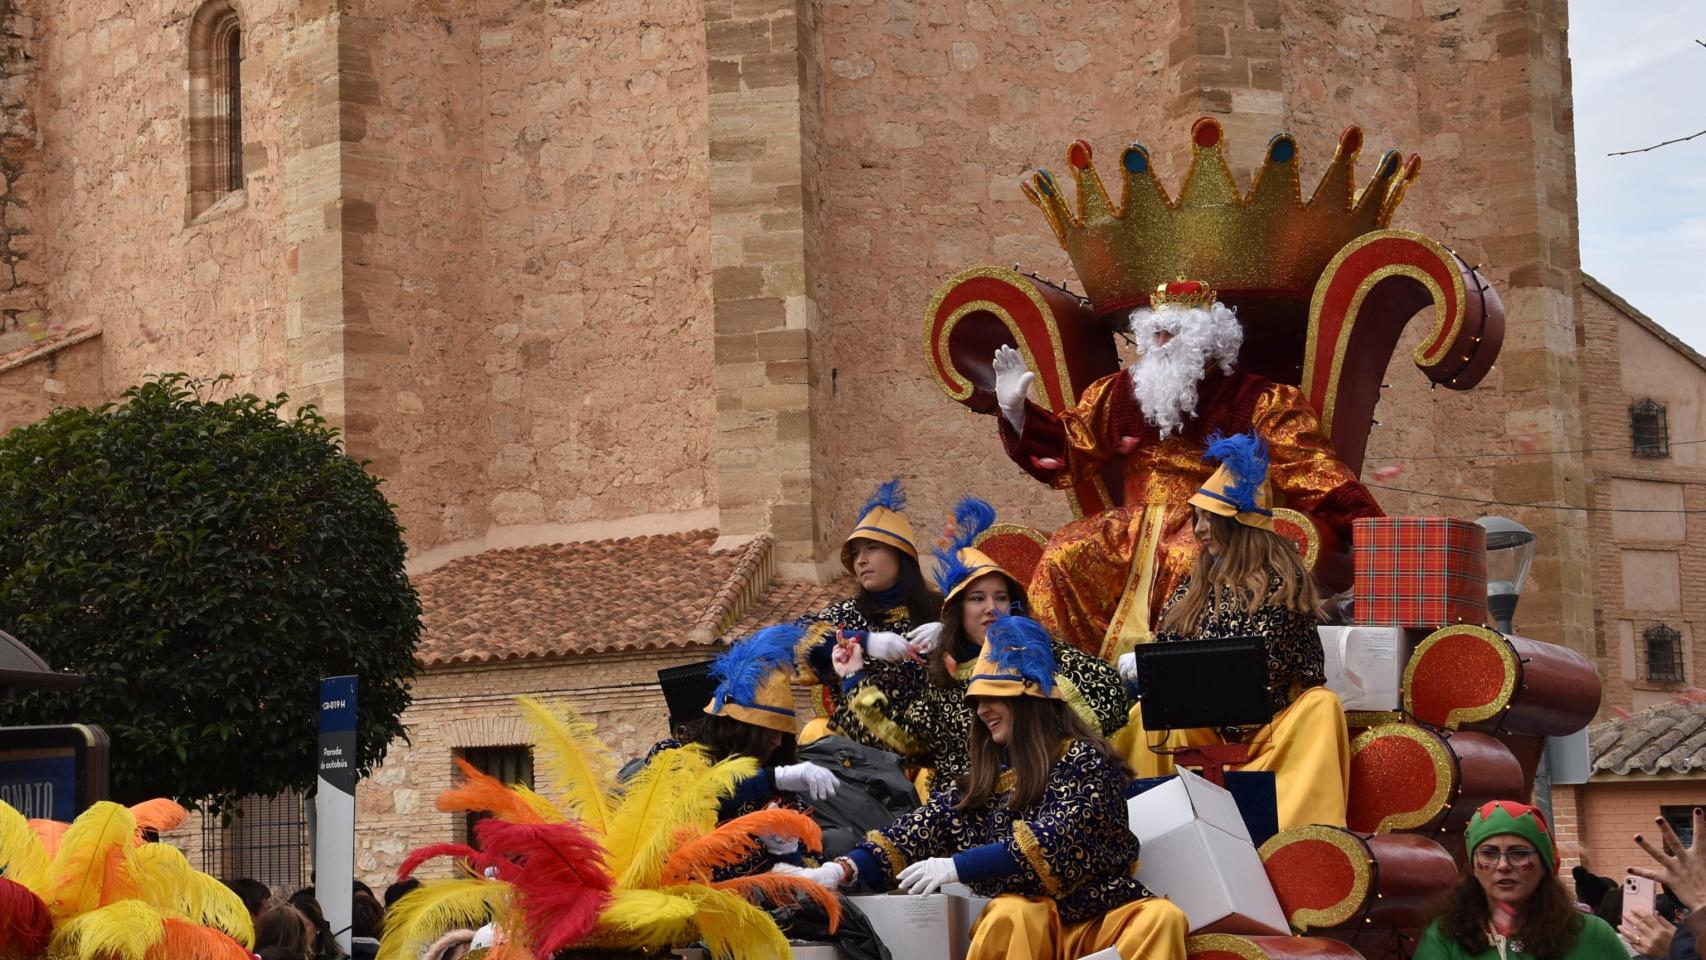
[966,893,1189,960]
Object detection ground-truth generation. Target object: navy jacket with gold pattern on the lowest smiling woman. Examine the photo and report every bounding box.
[850,740,1150,924]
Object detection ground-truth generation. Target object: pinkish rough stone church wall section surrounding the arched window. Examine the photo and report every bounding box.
[27,0,290,396]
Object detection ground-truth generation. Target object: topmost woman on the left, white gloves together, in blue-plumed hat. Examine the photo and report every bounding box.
[795,479,942,754]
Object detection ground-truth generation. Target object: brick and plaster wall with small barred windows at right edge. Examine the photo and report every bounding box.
[1576,281,1706,711]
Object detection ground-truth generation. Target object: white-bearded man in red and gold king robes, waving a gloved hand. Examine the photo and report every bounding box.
[995,281,1380,660]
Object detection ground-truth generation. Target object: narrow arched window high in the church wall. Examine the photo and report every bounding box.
[186,0,242,220]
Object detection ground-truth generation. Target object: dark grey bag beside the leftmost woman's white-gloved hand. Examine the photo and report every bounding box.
[800,737,918,859]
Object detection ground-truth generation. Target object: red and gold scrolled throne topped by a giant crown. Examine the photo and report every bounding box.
[925,118,1505,590]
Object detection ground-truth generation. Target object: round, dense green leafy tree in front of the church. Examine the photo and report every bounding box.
[0,373,420,808]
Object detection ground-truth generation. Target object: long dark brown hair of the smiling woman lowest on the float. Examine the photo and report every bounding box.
[954,696,1131,812]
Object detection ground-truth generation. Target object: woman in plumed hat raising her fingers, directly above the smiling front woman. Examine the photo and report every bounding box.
[838,496,1131,783]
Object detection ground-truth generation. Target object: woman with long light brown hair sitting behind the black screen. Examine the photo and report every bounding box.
[1119,433,1351,830]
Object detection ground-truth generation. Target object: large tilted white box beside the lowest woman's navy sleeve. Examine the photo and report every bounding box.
[1126,767,1290,936]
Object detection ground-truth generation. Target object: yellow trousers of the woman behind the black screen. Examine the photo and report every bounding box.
[1114,687,1351,830]
